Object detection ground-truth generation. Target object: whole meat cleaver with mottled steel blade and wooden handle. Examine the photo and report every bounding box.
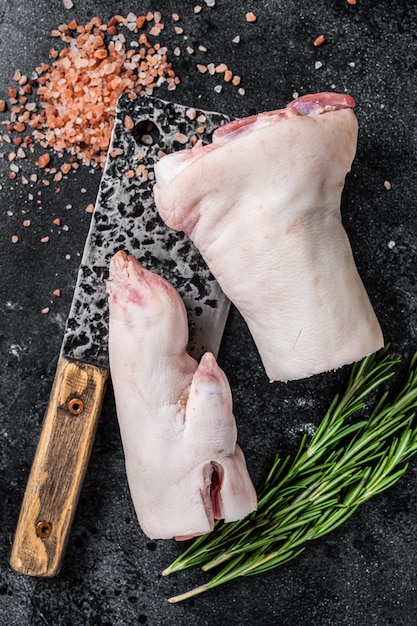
[10,93,230,576]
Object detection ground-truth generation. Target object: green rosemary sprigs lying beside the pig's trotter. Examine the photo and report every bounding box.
[163,345,417,602]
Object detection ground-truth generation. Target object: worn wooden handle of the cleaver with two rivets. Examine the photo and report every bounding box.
[10,357,108,576]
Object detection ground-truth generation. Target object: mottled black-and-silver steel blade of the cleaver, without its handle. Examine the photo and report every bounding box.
[62,94,229,366]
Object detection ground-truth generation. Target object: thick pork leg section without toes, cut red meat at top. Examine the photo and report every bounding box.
[154,93,383,381]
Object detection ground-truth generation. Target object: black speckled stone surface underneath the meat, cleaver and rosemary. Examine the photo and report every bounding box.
[0,0,417,626]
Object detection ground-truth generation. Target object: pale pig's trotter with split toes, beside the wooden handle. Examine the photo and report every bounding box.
[108,251,257,539]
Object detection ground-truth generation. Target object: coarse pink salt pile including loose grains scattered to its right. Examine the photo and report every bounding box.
[0,5,250,185]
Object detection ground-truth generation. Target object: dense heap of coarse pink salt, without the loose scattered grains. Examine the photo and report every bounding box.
[0,12,179,167]
